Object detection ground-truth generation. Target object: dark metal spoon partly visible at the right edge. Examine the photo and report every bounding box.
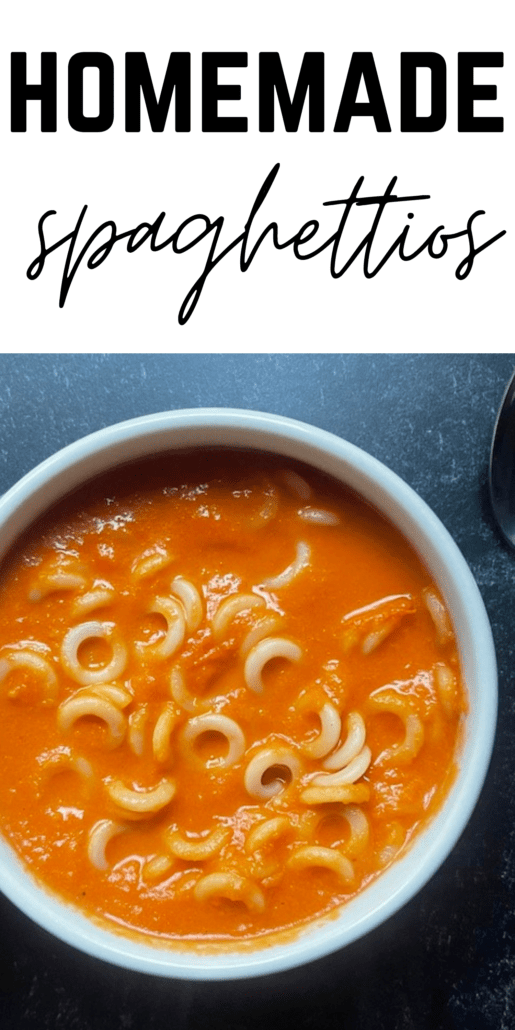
[488,372,515,548]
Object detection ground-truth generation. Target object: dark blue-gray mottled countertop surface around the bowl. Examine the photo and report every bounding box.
[0,354,515,1030]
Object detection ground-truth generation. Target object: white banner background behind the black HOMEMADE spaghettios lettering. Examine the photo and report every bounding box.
[1,0,514,352]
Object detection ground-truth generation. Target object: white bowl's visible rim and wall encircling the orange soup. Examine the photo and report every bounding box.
[0,408,496,980]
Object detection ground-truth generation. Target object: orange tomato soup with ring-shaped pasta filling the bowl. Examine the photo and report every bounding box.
[0,450,467,947]
